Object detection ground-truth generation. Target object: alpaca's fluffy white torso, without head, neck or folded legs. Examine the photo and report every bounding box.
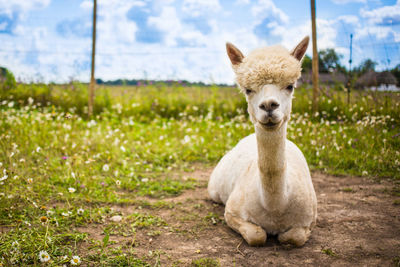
[208,134,317,234]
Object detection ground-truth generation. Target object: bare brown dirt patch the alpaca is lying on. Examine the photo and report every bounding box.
[82,170,400,266]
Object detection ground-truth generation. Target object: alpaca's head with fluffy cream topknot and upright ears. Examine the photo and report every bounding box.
[226,36,309,131]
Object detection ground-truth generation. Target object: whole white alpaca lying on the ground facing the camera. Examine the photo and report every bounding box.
[208,37,317,246]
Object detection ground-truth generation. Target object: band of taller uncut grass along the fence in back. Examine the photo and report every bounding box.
[0,83,400,123]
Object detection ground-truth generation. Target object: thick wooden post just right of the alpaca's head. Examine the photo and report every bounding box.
[311,0,319,112]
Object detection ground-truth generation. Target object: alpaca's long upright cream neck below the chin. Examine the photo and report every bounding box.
[255,123,287,208]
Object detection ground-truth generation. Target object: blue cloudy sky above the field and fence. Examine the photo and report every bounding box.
[0,0,400,83]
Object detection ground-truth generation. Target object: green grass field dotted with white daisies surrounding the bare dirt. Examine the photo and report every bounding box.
[0,84,400,266]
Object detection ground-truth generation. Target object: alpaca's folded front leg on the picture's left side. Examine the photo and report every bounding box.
[225,212,267,246]
